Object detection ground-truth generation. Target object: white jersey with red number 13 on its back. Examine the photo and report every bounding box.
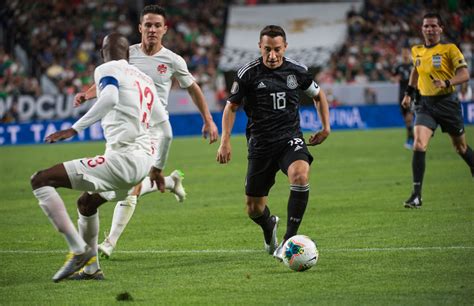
[94,60,168,151]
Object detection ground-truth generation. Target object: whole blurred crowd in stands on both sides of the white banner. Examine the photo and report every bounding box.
[0,0,474,119]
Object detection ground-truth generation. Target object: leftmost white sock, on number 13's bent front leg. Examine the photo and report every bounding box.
[33,186,86,254]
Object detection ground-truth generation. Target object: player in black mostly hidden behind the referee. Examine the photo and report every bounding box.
[393,48,414,150]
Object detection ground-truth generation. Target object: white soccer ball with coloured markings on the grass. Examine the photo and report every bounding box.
[283,235,319,271]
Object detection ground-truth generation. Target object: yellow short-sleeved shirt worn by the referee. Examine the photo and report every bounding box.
[411,43,467,96]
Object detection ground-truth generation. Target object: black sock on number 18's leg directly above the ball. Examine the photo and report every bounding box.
[283,184,309,240]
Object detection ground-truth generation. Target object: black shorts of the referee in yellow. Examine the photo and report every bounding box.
[415,94,464,136]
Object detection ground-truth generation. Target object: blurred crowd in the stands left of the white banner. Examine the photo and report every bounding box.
[0,0,226,104]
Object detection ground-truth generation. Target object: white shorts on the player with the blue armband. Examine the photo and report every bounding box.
[64,150,153,200]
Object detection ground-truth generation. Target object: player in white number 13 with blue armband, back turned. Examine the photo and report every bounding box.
[31,33,167,282]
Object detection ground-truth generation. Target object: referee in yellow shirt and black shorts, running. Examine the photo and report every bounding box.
[402,13,474,208]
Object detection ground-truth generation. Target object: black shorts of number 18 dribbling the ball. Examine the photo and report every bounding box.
[245,138,313,197]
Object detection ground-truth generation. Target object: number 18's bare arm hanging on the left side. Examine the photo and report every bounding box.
[216,101,239,164]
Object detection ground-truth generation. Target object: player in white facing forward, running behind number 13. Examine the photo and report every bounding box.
[75,5,219,258]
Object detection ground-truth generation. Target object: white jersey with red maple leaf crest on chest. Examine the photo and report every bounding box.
[129,44,195,107]
